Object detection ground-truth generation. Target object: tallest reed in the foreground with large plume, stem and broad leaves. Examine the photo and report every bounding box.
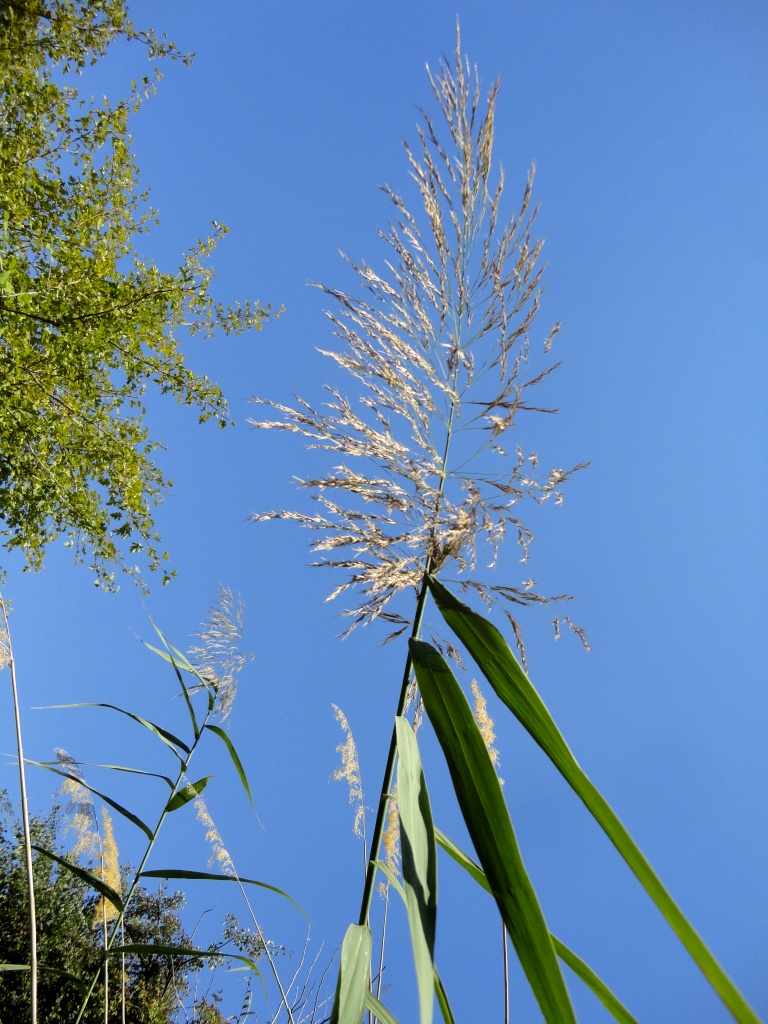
[251,29,757,1024]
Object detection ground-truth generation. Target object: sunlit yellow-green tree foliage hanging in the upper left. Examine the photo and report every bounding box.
[0,0,268,587]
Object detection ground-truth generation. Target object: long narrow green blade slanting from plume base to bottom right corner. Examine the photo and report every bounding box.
[428,577,760,1024]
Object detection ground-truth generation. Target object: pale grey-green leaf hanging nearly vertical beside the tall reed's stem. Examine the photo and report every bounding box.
[394,718,437,1024]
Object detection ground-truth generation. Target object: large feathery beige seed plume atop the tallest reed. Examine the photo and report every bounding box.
[250,29,582,663]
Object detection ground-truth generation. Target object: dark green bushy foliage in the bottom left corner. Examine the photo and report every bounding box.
[0,797,201,1024]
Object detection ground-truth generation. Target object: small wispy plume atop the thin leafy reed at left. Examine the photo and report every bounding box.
[187,586,248,719]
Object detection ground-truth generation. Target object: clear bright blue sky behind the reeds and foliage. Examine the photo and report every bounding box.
[0,0,768,1024]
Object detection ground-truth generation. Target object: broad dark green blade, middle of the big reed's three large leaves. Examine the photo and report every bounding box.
[409,639,575,1024]
